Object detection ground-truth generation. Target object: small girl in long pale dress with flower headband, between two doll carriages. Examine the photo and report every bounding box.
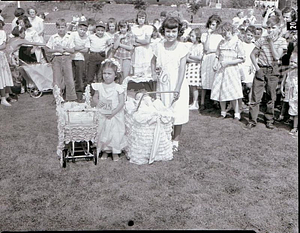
[92,58,127,161]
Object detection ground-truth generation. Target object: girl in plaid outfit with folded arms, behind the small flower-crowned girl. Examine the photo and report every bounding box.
[114,20,134,83]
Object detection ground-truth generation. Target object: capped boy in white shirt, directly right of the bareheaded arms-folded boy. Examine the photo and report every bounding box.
[71,21,88,101]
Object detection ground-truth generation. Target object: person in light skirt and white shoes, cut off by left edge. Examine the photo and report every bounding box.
[0,20,14,107]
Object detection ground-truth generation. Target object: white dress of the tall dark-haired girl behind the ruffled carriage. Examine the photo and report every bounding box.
[153,42,189,125]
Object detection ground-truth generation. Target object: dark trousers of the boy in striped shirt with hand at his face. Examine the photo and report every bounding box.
[249,67,279,124]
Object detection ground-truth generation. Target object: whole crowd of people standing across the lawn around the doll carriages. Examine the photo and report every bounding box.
[0,4,298,160]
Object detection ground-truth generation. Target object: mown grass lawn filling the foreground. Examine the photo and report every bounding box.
[0,93,298,233]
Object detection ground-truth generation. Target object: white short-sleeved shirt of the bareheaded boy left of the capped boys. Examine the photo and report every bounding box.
[46,32,75,55]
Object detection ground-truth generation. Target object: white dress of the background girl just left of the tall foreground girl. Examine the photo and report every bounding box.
[131,25,153,76]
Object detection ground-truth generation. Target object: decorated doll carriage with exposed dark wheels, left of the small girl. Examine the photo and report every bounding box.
[53,85,98,168]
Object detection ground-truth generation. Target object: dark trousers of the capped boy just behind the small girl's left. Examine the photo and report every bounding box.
[84,52,105,86]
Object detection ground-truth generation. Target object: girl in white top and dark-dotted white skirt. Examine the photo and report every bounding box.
[185,28,203,110]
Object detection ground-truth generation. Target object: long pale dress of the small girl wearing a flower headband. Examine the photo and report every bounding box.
[92,82,127,153]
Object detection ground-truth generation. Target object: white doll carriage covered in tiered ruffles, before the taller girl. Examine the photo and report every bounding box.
[123,77,174,165]
